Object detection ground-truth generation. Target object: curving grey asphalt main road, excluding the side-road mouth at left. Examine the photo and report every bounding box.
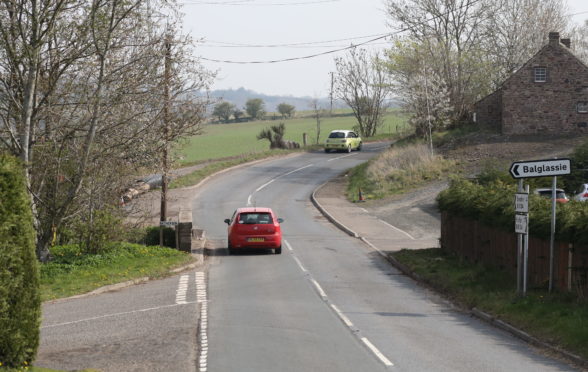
[192,144,572,372]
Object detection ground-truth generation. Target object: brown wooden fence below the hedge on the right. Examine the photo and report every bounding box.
[441,212,588,297]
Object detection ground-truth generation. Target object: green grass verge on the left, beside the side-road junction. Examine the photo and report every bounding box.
[41,243,194,301]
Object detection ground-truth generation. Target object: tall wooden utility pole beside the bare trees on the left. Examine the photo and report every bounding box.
[159,34,171,246]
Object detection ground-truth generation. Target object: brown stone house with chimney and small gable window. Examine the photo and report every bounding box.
[474,32,588,134]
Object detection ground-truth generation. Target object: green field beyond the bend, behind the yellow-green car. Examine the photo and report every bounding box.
[177,110,407,165]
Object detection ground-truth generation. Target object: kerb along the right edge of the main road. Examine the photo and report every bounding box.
[310,180,588,367]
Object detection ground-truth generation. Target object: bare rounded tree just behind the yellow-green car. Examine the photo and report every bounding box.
[335,48,390,137]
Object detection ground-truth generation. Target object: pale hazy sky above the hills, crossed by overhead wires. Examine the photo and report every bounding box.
[180,0,588,98]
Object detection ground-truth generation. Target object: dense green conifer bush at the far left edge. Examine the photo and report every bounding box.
[0,154,41,367]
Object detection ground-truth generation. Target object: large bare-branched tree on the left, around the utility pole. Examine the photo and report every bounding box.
[0,0,210,260]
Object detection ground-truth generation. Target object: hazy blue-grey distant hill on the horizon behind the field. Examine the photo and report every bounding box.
[210,88,336,112]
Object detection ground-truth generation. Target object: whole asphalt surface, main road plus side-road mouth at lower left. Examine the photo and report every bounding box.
[35,144,571,372]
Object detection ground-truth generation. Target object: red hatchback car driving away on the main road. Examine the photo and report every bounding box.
[225,207,284,254]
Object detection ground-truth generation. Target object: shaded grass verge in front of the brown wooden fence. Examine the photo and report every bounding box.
[392,248,588,359]
